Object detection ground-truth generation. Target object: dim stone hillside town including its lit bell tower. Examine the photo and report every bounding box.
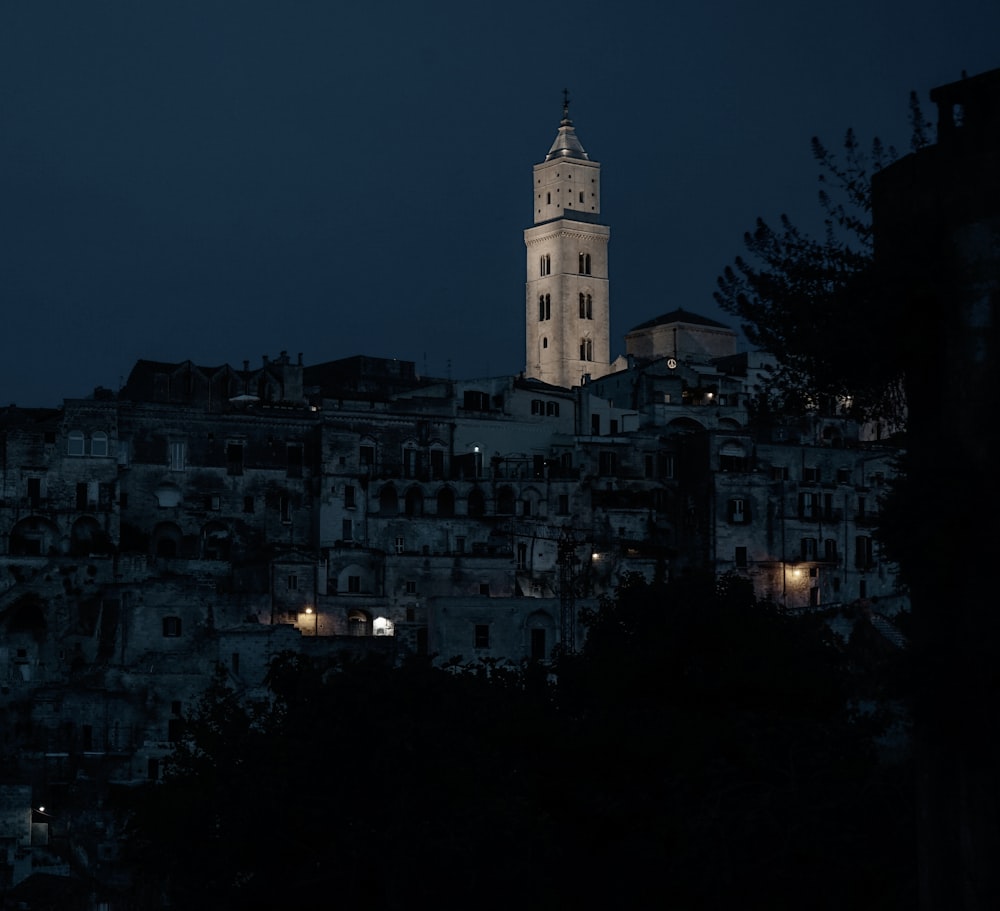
[0,94,920,904]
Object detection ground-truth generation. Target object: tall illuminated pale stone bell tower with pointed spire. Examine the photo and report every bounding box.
[524,93,611,388]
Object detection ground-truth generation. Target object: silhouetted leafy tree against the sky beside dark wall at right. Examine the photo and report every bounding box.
[715,130,902,419]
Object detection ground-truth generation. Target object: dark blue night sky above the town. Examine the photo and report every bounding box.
[0,0,1000,407]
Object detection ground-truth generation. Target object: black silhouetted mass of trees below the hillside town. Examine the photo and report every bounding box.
[119,578,915,909]
